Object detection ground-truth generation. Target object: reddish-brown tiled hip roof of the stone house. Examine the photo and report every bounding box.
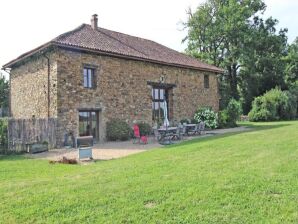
[4,24,223,73]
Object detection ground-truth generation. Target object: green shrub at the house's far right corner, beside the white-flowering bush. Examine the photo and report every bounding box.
[218,99,242,128]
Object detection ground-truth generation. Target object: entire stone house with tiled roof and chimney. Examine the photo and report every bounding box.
[3,15,222,146]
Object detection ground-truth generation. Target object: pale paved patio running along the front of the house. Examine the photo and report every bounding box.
[26,127,250,161]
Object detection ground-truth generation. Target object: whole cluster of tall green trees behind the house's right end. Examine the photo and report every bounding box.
[184,0,292,114]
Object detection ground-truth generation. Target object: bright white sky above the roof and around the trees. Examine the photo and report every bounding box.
[0,0,298,78]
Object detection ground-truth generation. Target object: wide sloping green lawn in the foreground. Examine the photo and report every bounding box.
[0,121,298,223]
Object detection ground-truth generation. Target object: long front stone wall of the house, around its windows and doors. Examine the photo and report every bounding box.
[57,50,219,144]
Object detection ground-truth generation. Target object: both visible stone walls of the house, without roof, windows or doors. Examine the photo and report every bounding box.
[11,49,219,145]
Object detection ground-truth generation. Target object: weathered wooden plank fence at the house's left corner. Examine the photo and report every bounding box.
[8,118,57,152]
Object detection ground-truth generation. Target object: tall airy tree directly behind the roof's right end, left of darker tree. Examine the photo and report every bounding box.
[184,0,265,99]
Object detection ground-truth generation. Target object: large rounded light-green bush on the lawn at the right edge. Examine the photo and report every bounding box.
[248,88,297,121]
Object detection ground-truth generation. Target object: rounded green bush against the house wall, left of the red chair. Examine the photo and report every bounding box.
[106,119,132,141]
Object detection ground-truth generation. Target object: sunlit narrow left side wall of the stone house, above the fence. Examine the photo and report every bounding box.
[10,52,57,118]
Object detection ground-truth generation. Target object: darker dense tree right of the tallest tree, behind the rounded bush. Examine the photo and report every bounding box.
[239,17,287,114]
